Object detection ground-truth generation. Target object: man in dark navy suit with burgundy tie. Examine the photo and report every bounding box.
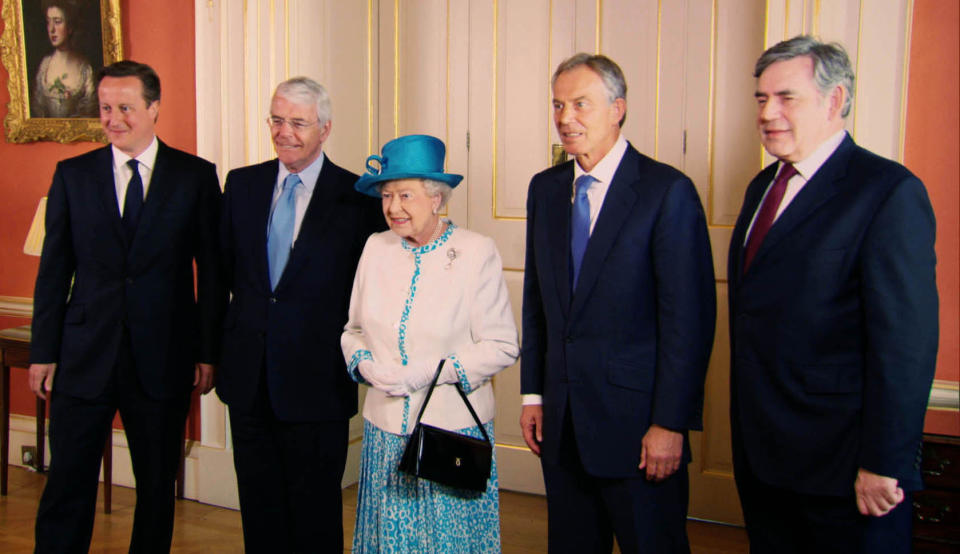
[727,36,938,553]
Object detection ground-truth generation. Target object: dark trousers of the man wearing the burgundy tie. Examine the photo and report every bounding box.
[736,463,913,554]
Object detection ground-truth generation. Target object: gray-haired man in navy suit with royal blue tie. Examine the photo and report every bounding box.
[520,54,716,553]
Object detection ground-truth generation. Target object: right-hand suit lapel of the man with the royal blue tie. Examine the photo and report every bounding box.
[567,146,640,317]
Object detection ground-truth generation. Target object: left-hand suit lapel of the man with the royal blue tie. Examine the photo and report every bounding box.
[546,162,574,315]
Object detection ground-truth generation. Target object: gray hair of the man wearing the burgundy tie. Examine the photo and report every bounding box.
[753,35,856,117]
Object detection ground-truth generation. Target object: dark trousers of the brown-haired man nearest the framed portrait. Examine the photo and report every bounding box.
[35,332,190,553]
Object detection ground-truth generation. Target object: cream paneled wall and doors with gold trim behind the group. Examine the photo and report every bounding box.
[188,0,912,522]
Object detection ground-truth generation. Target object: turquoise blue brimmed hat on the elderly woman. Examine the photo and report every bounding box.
[353,135,463,198]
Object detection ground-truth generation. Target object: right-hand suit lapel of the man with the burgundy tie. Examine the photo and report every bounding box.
[747,135,854,273]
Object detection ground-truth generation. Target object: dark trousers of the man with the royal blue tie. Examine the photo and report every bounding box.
[541,412,690,554]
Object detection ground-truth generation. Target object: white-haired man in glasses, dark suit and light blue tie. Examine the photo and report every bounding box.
[217,77,386,552]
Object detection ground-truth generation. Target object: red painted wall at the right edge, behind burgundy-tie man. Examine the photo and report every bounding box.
[903,0,960,435]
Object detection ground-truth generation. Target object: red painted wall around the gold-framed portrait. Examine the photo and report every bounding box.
[0,0,200,437]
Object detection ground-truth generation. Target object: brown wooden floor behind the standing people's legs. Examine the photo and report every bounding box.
[0,467,747,554]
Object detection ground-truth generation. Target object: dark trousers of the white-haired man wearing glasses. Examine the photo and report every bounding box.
[230,368,349,554]
